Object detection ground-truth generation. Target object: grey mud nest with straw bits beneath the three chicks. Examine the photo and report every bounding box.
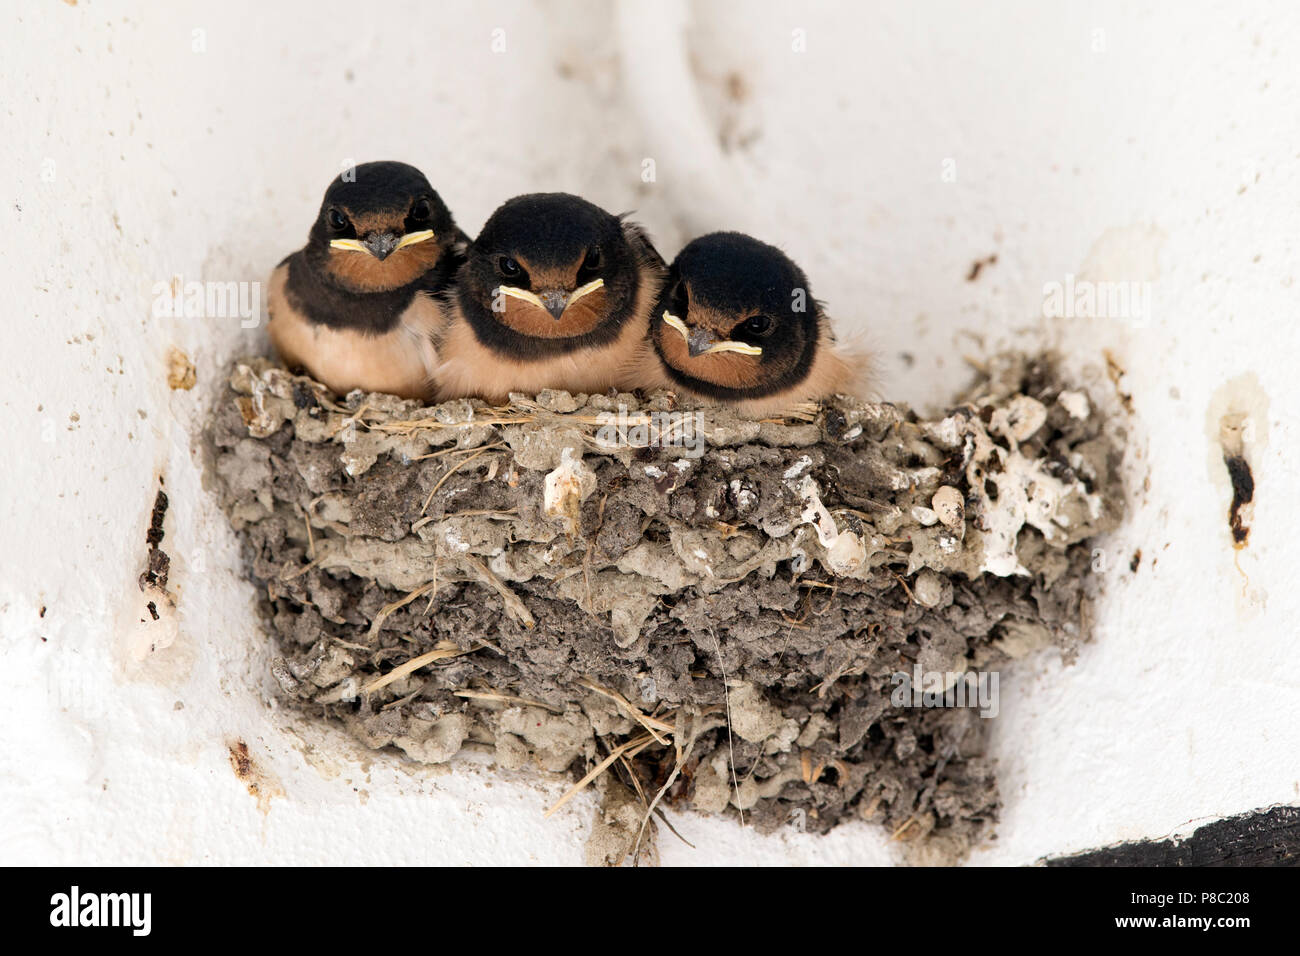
[209,355,1122,862]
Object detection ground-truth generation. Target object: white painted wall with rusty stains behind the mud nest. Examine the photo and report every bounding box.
[0,0,1300,864]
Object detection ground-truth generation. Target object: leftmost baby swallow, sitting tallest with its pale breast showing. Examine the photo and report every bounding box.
[267,163,468,398]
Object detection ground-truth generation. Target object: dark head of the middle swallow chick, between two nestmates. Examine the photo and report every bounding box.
[458,193,662,358]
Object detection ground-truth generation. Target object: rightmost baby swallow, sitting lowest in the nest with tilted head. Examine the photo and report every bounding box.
[623,233,863,418]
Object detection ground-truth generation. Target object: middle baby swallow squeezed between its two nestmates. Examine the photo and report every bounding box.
[437,193,664,403]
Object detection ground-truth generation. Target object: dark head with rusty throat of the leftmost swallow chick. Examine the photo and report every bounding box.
[306,163,463,293]
